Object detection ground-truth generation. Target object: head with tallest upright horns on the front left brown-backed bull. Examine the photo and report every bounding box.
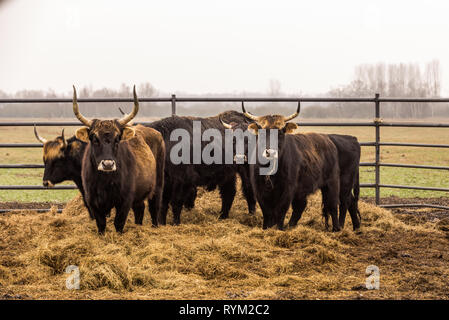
[73,86,139,172]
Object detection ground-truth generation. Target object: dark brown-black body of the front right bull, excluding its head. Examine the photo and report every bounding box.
[250,133,339,231]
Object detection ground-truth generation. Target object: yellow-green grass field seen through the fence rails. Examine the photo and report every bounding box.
[0,119,449,202]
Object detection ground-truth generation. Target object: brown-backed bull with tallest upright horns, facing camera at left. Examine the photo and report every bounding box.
[73,87,163,234]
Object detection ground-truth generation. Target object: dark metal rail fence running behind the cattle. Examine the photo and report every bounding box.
[0,94,449,212]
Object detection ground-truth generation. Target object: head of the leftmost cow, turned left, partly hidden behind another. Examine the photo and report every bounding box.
[34,126,86,187]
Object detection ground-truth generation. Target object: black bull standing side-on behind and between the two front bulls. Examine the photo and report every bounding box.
[149,111,256,224]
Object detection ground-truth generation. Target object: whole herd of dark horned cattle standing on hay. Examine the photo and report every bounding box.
[34,87,360,234]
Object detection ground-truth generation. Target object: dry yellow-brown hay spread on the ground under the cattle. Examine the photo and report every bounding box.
[0,190,449,299]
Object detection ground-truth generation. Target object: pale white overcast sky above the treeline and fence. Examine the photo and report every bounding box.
[0,0,449,96]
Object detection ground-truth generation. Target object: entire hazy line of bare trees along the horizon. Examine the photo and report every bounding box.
[0,60,449,119]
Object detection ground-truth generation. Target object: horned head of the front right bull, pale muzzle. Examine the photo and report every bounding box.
[242,102,301,158]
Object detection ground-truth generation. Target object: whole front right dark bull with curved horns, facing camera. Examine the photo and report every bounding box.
[222,103,340,231]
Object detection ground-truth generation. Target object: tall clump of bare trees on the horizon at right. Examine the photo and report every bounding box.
[309,60,449,118]
